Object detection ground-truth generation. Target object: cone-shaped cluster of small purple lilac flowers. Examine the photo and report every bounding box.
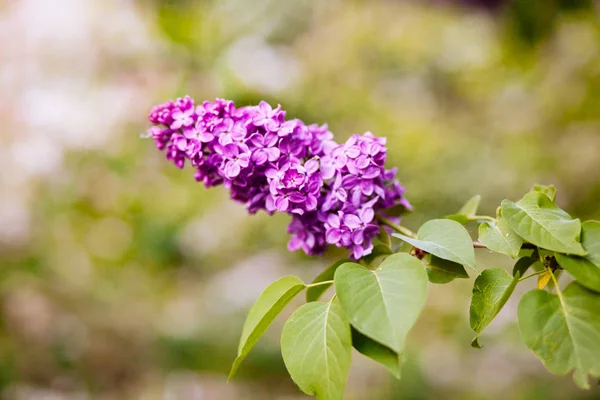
[149,96,410,259]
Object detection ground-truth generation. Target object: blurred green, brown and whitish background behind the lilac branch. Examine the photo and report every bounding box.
[0,0,600,400]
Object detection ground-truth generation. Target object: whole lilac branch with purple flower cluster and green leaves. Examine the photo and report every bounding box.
[149,97,600,394]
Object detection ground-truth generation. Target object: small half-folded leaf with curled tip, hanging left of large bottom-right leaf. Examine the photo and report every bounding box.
[469,268,520,348]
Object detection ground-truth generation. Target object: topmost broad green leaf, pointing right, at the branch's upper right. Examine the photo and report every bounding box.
[501,191,586,256]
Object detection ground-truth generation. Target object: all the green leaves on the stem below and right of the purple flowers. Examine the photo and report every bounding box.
[230,186,600,400]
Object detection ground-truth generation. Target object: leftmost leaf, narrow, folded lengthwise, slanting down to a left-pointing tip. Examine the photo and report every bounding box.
[228,276,305,379]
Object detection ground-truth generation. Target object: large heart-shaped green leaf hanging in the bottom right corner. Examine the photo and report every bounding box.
[518,282,600,389]
